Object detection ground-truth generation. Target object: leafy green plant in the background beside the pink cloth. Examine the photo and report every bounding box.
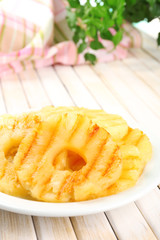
[67,0,160,64]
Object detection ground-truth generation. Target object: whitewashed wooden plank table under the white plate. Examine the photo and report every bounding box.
[0,35,160,240]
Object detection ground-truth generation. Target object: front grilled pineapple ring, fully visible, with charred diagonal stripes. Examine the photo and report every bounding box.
[14,113,122,202]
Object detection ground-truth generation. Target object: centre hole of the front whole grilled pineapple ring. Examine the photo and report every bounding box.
[53,150,86,171]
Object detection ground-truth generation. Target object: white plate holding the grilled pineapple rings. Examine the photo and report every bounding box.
[0,111,160,217]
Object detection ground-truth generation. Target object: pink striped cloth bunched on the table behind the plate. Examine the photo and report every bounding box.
[0,0,141,76]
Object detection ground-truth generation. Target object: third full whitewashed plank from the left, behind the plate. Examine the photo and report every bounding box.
[38,67,73,106]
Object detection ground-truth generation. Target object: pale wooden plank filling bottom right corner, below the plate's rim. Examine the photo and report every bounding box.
[136,188,160,239]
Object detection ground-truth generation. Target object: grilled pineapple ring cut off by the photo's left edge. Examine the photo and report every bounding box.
[0,114,41,198]
